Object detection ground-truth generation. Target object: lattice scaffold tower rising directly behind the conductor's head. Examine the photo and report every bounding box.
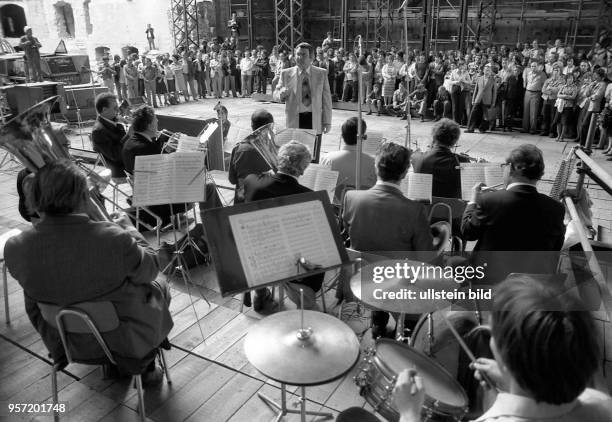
[275,0,304,51]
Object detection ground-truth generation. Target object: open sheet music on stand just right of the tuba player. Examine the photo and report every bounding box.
[133,152,206,207]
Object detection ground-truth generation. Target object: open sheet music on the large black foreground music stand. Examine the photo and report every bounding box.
[229,201,341,287]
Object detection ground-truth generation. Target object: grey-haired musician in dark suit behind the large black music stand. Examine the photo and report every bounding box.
[244,141,325,312]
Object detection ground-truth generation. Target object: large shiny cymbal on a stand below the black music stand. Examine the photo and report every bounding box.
[244,310,359,385]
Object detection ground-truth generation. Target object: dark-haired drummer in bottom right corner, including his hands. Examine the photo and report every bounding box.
[388,277,612,422]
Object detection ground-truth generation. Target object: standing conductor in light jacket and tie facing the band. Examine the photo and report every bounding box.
[273,43,332,162]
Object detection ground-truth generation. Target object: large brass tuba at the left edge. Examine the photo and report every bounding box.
[0,96,111,221]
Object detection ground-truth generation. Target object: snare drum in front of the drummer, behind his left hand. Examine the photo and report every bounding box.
[355,339,468,422]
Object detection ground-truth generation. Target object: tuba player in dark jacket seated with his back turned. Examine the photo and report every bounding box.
[4,160,172,382]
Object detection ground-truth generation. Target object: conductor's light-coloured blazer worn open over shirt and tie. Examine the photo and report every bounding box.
[273,66,332,135]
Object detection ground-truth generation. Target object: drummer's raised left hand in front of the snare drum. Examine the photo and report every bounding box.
[393,369,425,422]
